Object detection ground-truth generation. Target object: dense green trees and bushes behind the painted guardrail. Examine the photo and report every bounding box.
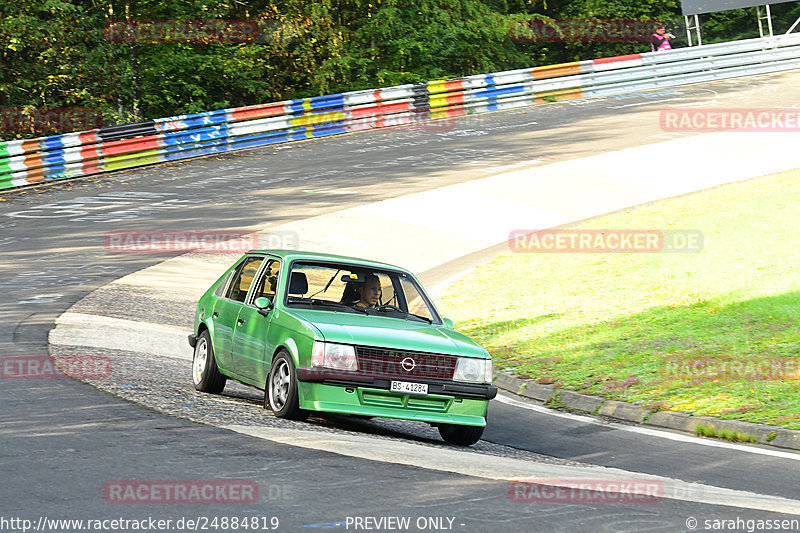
[0,0,800,138]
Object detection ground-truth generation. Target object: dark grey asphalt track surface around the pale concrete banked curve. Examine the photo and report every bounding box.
[0,73,800,532]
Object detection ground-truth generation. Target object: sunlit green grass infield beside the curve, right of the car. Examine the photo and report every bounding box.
[441,170,800,429]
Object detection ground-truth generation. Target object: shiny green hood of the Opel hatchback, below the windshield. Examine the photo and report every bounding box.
[286,309,489,357]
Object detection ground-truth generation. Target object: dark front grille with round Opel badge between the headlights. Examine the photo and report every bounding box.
[356,346,456,380]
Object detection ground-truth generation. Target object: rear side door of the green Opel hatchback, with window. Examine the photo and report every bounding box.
[212,256,264,374]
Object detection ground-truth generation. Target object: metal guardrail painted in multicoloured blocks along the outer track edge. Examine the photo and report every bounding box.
[0,34,800,189]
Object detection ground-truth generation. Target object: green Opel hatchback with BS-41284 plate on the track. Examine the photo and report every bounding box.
[189,250,497,446]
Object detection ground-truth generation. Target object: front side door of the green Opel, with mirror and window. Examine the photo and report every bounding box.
[233,258,281,387]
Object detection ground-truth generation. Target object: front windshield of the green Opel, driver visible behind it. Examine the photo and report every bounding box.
[286,261,440,323]
